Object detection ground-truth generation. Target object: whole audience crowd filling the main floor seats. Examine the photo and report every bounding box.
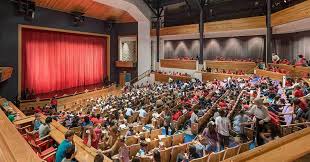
[3,75,310,162]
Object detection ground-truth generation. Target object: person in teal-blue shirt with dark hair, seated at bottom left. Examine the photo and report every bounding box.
[56,130,77,162]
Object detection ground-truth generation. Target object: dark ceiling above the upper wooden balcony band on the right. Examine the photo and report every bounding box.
[143,0,305,27]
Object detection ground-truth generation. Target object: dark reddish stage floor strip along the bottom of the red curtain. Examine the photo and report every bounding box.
[31,83,106,99]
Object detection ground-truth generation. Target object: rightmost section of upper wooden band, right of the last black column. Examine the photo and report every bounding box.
[271,0,310,26]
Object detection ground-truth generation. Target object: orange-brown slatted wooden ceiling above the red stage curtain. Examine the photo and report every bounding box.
[34,0,136,23]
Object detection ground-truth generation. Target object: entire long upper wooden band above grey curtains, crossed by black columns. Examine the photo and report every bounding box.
[151,0,310,36]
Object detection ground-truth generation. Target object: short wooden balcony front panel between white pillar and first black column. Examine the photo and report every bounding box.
[160,59,197,70]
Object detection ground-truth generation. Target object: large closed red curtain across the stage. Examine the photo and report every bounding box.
[22,28,107,94]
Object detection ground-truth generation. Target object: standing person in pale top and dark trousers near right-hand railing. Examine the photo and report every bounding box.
[247,98,270,146]
